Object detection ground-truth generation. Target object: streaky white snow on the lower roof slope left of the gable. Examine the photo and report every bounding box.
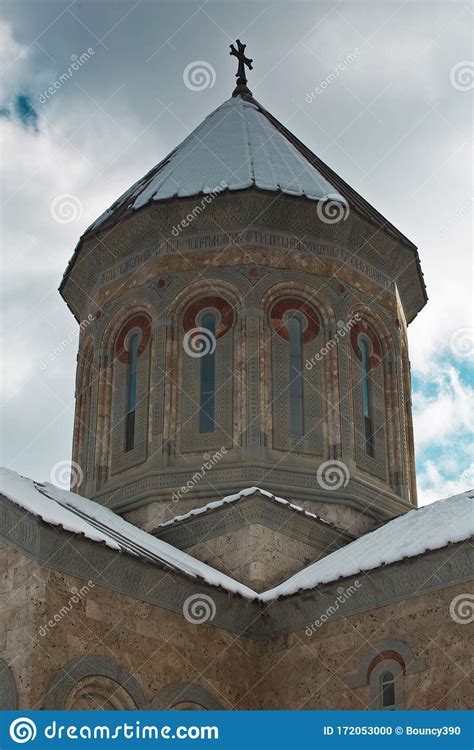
[0,468,257,598]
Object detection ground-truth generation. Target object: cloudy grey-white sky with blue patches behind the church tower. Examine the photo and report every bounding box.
[0,0,474,503]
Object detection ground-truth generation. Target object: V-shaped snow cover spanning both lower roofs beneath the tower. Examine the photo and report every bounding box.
[0,469,474,602]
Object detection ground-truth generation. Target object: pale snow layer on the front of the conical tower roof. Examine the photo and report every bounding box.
[87,96,347,231]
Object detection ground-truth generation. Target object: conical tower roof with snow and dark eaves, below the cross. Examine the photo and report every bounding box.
[59,85,427,322]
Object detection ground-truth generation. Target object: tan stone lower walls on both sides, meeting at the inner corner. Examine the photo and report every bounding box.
[0,548,470,710]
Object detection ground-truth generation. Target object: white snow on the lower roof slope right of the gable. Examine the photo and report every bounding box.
[260,490,474,602]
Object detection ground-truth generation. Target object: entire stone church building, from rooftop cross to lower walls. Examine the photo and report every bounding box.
[0,51,472,710]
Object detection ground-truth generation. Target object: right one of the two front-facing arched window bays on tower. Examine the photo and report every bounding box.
[260,281,339,456]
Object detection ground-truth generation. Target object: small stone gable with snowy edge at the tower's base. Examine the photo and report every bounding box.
[154,490,352,592]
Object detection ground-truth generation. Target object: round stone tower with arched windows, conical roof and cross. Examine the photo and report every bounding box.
[60,43,426,536]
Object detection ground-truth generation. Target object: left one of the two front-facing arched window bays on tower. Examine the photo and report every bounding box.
[163,279,246,454]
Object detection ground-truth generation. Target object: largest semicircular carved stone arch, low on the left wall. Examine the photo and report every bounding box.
[44,656,146,710]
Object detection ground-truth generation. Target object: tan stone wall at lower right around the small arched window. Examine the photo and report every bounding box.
[250,584,474,710]
